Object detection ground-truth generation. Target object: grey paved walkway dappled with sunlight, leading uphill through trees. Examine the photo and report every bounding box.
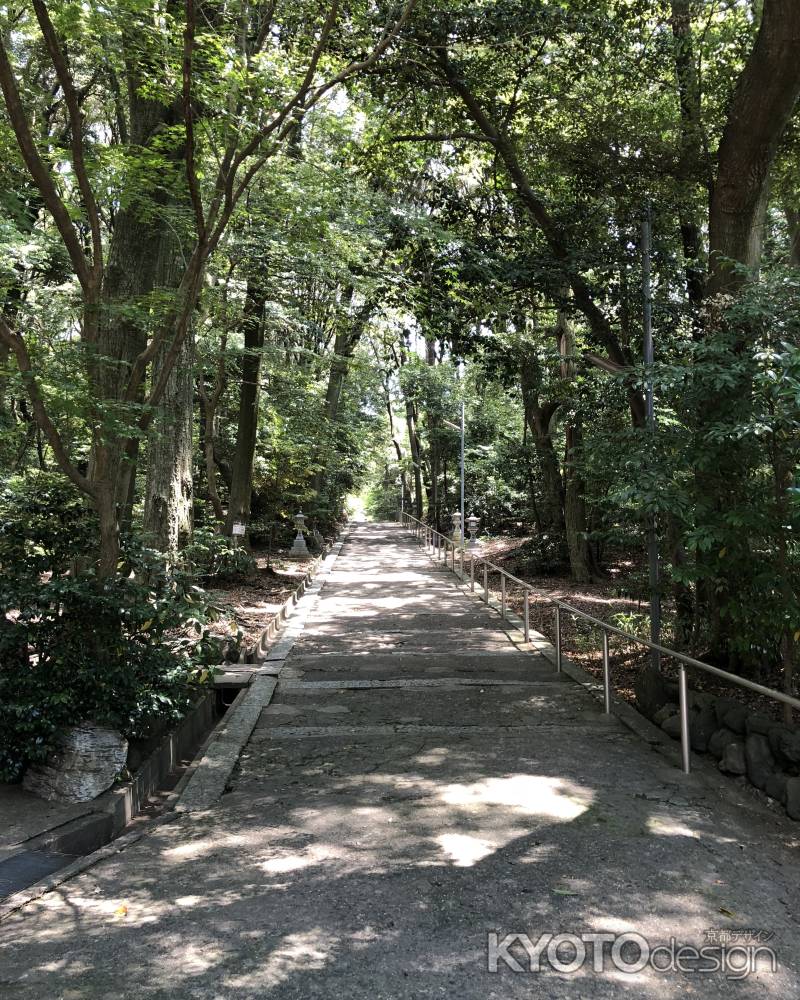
[0,525,800,1000]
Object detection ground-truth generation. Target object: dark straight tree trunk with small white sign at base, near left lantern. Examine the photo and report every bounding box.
[225,281,265,535]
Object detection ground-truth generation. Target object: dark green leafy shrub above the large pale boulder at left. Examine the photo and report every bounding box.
[0,477,222,781]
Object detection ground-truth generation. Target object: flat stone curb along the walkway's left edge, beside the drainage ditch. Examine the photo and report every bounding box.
[175,527,349,813]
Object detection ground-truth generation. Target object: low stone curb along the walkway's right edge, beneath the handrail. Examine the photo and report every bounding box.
[420,546,785,822]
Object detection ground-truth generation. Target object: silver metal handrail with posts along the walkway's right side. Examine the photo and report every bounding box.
[402,511,800,774]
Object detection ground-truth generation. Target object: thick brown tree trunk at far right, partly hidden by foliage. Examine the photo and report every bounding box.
[695,0,800,662]
